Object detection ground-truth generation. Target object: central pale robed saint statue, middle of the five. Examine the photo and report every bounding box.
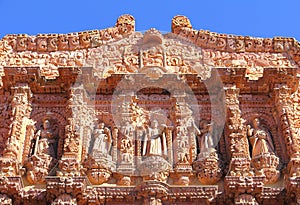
[143,120,167,156]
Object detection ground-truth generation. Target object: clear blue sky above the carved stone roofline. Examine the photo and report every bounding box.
[0,0,300,40]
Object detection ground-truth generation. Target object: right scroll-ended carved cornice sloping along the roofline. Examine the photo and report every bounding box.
[172,15,300,65]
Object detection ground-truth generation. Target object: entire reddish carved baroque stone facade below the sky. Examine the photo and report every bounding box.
[0,15,300,205]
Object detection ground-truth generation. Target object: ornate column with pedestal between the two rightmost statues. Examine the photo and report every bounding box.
[224,85,264,205]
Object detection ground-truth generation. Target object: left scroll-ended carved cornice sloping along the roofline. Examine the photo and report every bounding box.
[0,14,135,53]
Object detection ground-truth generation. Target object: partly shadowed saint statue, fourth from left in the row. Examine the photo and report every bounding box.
[198,121,215,153]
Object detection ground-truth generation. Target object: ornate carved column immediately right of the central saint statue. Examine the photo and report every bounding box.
[169,90,196,186]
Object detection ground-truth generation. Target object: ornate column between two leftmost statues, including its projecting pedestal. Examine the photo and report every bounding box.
[46,81,91,205]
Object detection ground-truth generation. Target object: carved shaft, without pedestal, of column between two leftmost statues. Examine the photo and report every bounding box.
[57,86,94,176]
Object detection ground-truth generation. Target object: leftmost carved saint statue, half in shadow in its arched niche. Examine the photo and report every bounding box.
[33,119,57,158]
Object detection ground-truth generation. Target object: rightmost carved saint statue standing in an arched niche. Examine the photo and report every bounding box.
[247,118,274,158]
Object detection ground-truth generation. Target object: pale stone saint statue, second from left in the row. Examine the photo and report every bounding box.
[92,122,112,155]
